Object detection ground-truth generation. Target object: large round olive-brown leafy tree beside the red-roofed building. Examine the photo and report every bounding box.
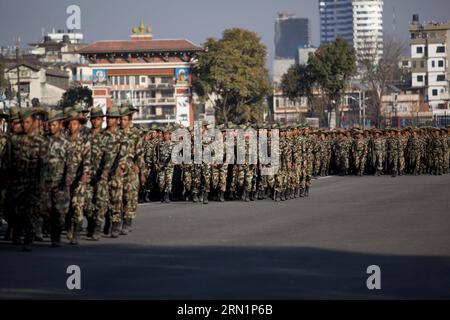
[193,28,271,122]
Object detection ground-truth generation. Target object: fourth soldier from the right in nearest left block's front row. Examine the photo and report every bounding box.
[65,111,91,245]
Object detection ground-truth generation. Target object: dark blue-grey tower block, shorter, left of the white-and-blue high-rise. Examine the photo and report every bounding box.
[275,13,311,59]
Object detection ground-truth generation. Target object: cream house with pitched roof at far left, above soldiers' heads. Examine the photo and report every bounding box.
[5,63,69,106]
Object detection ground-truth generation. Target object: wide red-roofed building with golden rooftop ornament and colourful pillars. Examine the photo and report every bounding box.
[79,22,202,126]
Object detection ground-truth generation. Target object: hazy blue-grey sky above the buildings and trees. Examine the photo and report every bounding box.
[0,0,450,67]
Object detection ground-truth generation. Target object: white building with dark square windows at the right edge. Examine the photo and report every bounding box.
[409,15,450,122]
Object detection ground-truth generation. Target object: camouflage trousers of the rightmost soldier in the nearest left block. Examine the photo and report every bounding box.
[122,164,140,220]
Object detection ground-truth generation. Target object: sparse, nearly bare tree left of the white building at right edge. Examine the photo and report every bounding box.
[358,38,406,128]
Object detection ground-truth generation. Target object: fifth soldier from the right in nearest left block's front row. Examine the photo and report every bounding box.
[42,110,75,247]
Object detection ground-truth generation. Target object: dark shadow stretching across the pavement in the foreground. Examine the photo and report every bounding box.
[0,243,450,299]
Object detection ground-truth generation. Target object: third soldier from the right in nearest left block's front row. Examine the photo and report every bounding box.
[86,107,111,241]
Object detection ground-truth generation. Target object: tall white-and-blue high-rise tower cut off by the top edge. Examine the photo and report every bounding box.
[319,0,383,61]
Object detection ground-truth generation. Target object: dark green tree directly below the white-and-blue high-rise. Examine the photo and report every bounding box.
[308,38,356,127]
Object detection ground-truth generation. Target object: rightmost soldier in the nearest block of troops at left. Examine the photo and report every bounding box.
[119,107,146,235]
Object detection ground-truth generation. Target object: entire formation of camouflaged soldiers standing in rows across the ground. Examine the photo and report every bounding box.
[0,105,450,251]
